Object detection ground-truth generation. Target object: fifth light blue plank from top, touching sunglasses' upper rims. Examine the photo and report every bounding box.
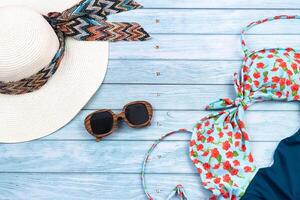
[85,84,300,110]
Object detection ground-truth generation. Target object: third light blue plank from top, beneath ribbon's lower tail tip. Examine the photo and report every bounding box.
[110,34,300,60]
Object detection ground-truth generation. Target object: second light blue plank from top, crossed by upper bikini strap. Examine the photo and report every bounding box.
[110,9,300,35]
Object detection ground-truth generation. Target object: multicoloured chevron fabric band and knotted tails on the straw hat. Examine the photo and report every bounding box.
[0,0,150,95]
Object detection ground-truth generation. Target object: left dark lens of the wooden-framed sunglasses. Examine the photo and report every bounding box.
[91,111,114,135]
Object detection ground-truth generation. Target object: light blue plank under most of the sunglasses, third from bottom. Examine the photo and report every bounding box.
[44,110,300,141]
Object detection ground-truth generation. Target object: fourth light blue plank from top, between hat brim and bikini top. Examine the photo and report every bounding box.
[104,60,242,84]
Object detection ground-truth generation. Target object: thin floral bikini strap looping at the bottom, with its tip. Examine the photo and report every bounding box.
[141,129,192,200]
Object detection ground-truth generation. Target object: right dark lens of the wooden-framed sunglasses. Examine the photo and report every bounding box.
[125,103,150,125]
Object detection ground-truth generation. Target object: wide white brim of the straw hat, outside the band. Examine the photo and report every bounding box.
[0,0,109,143]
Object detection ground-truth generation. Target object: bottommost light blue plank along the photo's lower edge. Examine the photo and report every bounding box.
[0,173,208,200]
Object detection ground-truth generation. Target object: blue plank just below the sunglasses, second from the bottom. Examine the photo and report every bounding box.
[0,140,278,174]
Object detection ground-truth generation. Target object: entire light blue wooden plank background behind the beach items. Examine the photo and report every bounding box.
[0,0,300,200]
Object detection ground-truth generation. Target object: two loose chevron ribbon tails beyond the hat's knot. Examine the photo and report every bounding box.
[48,0,150,41]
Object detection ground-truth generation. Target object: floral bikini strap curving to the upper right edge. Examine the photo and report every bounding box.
[241,15,300,56]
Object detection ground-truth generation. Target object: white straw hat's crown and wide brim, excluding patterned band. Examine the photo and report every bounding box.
[0,0,149,143]
